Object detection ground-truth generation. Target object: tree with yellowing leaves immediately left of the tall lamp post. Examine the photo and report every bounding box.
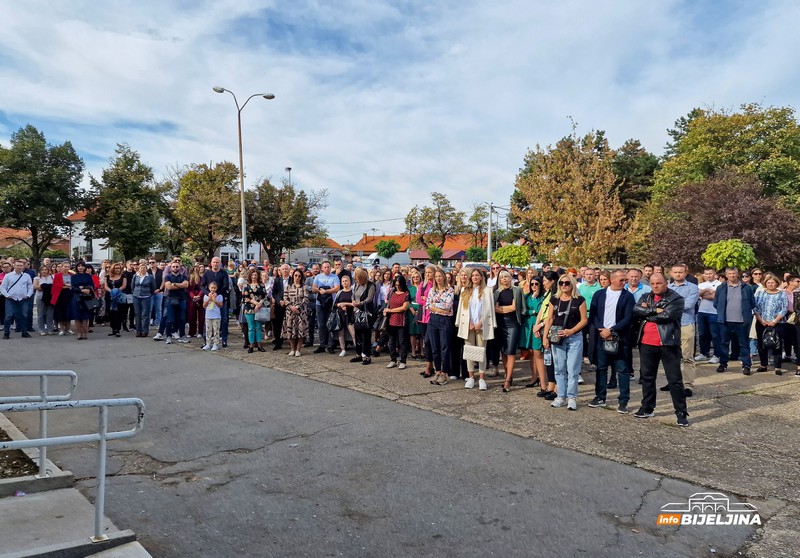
[173,161,242,261]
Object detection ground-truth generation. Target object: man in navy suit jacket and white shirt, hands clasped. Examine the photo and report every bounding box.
[589,270,634,414]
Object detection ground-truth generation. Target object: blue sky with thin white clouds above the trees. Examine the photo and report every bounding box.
[0,0,800,243]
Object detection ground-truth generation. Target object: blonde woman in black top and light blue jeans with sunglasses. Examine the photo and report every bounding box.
[542,275,589,411]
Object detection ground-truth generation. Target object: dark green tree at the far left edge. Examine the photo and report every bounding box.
[0,124,85,266]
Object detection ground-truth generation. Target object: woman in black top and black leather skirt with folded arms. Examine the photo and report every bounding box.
[494,269,524,393]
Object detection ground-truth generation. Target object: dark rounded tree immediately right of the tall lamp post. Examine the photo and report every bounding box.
[246,179,328,263]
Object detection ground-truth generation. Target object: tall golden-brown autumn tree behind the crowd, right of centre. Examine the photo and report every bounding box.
[512,131,624,264]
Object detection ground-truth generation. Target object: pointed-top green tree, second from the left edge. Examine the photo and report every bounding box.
[85,144,165,260]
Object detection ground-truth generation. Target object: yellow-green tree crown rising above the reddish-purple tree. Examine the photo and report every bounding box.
[653,104,800,204]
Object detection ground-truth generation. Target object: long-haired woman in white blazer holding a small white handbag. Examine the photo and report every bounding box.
[456,269,497,390]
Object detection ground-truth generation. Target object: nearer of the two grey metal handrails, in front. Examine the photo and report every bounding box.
[0,398,144,542]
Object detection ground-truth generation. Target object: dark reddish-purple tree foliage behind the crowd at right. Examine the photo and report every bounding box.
[647,171,800,268]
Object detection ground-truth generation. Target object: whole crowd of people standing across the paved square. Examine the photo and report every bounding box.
[0,257,800,426]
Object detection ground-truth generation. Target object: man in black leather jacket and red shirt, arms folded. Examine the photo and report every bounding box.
[633,273,689,426]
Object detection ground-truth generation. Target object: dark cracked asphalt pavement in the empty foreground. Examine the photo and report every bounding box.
[2,334,776,557]
